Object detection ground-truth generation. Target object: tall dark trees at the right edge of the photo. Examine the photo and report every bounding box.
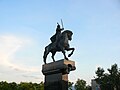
[95,64,120,90]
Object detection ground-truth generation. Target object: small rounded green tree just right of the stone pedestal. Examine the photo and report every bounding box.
[75,79,86,90]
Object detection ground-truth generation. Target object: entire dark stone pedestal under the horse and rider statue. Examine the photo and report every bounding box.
[42,59,76,90]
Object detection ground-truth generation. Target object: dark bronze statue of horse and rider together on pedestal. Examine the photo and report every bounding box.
[43,23,75,64]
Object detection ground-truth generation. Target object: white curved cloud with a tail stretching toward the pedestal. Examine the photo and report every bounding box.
[0,35,39,72]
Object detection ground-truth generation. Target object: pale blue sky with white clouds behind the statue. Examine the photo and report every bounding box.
[0,0,120,84]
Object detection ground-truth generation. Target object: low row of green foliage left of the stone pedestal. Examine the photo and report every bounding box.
[0,81,44,90]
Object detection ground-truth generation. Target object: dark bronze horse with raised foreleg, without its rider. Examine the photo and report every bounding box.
[43,30,75,64]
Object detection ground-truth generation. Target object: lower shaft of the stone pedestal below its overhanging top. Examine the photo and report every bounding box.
[44,73,68,90]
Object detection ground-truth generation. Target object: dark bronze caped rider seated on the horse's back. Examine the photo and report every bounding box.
[50,23,64,44]
